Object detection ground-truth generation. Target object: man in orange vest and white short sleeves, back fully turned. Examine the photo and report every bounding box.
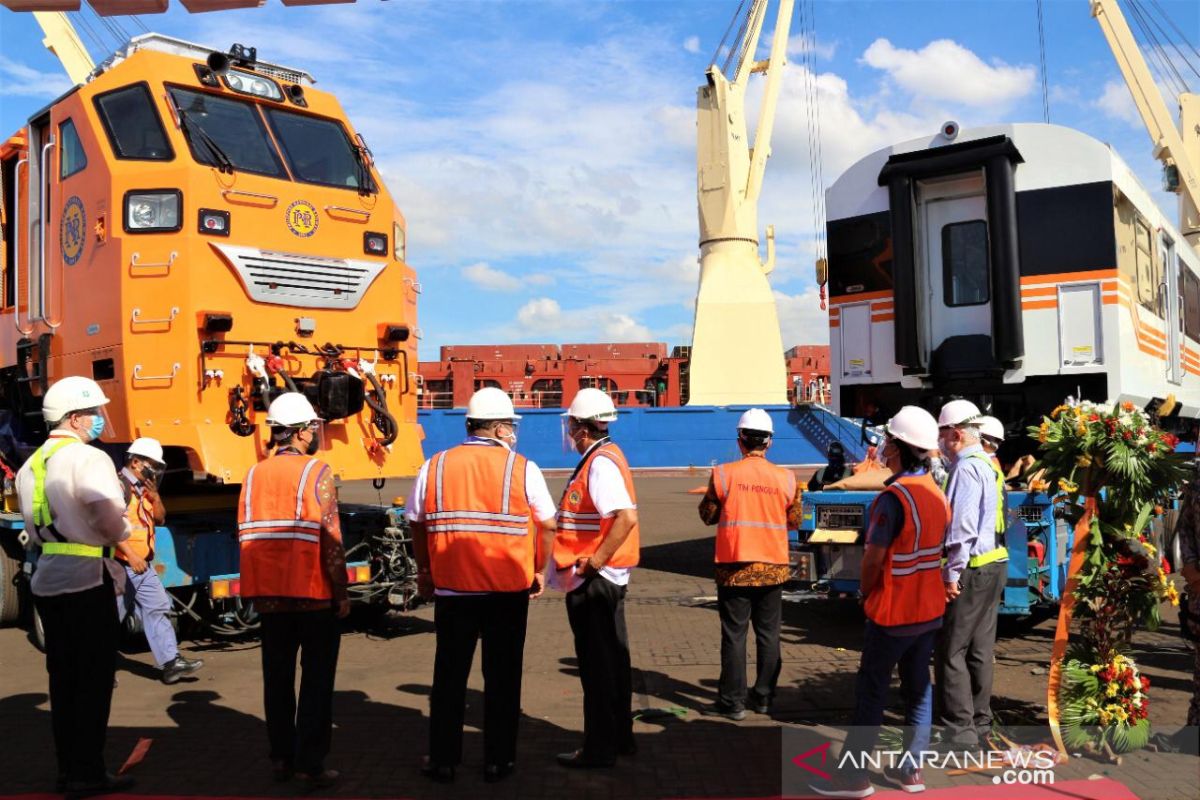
[406,387,556,783]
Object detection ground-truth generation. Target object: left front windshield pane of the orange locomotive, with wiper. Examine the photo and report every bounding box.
[169,88,287,179]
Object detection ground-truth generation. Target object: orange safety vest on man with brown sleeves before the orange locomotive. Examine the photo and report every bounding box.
[238,453,334,600]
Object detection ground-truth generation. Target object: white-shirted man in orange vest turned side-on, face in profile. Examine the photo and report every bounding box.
[551,389,640,768]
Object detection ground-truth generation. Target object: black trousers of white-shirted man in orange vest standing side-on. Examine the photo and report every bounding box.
[566,576,634,762]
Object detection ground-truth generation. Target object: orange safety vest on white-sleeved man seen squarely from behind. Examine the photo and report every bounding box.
[425,444,536,591]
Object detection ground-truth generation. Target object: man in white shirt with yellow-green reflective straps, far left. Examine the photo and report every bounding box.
[17,377,133,796]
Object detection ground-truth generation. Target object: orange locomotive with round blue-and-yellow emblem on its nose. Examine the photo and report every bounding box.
[0,34,422,483]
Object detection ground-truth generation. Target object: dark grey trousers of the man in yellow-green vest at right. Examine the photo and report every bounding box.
[934,561,1008,745]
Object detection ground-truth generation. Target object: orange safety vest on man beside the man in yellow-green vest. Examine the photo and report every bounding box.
[865,474,950,626]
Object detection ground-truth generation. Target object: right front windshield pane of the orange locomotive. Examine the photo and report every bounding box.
[266,108,376,192]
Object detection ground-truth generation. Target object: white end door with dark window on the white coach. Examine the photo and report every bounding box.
[918,176,991,363]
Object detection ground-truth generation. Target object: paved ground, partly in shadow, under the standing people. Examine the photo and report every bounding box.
[0,474,1200,800]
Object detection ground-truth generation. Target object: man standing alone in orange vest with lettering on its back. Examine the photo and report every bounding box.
[700,408,800,721]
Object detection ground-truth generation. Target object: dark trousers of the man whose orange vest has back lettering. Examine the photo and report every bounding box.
[716,584,784,709]
